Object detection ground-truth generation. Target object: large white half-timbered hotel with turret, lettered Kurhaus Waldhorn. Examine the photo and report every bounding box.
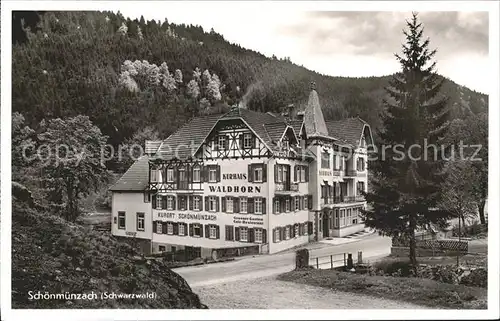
[111,85,372,258]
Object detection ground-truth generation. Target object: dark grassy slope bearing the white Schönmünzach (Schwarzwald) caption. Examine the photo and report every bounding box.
[12,201,204,308]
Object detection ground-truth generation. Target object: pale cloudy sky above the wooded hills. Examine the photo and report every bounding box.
[116,4,491,94]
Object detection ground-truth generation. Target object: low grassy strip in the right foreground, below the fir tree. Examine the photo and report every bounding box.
[278,270,487,309]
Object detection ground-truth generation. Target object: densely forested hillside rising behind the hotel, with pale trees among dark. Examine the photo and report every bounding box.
[12,12,488,149]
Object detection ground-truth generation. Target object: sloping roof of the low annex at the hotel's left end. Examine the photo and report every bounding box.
[109,156,149,191]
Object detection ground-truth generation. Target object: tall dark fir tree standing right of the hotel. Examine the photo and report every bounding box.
[364,13,450,268]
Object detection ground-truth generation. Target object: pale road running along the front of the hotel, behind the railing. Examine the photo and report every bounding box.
[175,233,391,287]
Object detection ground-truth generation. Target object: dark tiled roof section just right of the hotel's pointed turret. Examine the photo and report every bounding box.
[326,117,369,147]
